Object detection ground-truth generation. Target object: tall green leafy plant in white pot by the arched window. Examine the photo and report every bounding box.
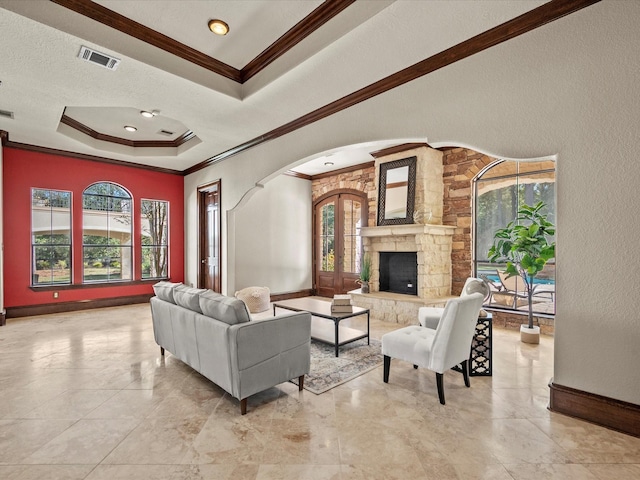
[488,202,556,343]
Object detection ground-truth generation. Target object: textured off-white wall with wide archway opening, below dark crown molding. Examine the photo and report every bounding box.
[185,1,640,404]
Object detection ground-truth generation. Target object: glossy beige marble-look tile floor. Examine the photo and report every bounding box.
[0,304,640,480]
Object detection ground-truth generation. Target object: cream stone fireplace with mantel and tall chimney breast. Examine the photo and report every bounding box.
[351,145,456,324]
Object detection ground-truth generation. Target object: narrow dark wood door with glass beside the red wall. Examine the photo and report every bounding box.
[198,182,221,293]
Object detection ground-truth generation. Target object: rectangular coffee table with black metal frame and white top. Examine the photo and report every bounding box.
[273,297,369,357]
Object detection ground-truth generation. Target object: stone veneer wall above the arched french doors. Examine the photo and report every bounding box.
[311,164,378,227]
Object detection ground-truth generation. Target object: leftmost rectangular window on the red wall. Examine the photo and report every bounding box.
[31,188,71,285]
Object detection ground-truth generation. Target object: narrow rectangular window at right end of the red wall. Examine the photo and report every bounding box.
[140,200,169,279]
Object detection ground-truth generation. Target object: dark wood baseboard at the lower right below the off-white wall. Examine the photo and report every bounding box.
[549,380,640,437]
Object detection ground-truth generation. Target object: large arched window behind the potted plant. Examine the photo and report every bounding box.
[474,160,556,315]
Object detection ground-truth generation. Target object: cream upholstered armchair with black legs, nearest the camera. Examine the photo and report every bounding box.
[382,293,484,405]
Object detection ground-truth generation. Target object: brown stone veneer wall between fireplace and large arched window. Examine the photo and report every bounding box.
[442,148,496,295]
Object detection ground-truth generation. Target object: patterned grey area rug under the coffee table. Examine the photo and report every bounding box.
[292,339,382,395]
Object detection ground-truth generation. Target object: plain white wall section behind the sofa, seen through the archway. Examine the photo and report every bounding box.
[233,175,312,293]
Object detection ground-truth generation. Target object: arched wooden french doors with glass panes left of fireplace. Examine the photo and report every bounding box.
[314,191,368,297]
